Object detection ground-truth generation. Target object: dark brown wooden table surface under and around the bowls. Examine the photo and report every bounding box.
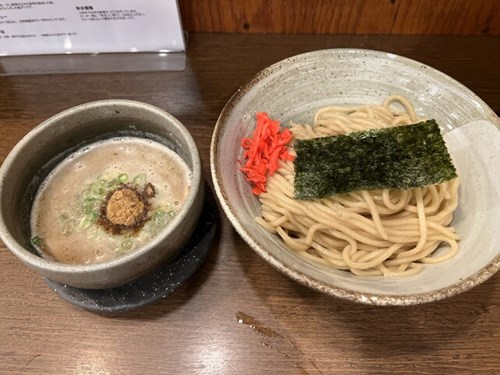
[0,34,500,374]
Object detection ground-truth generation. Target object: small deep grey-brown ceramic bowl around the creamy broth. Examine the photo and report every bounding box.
[0,100,205,289]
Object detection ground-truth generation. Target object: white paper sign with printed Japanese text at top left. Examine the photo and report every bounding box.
[0,0,185,56]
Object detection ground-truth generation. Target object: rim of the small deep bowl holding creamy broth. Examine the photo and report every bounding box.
[0,99,203,275]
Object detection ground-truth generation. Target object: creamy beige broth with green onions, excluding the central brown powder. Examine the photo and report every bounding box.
[31,137,191,264]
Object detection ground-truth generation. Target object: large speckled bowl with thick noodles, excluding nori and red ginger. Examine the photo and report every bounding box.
[211,49,500,305]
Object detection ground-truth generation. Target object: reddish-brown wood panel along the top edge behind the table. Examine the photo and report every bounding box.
[179,0,500,36]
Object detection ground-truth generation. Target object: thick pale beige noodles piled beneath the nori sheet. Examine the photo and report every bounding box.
[256,96,459,276]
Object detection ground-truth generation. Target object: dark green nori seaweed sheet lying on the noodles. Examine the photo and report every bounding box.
[294,120,457,199]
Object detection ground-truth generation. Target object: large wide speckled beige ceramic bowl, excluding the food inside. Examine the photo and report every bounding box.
[211,49,500,305]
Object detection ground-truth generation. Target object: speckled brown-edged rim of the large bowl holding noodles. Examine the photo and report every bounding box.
[210,48,500,306]
